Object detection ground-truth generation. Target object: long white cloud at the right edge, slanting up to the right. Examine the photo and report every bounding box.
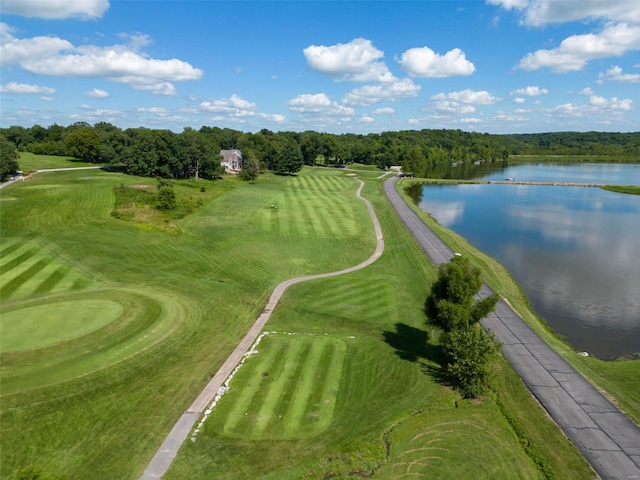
[518,23,640,73]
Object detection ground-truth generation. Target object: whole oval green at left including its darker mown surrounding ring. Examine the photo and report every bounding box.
[0,289,184,394]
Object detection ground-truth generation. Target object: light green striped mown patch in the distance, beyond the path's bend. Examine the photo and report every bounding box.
[253,176,358,239]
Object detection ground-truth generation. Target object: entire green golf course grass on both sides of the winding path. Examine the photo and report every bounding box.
[0,160,593,480]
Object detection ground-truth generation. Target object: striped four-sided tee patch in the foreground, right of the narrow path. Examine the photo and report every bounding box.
[209,335,347,439]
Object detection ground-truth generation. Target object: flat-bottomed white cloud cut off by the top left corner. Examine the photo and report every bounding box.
[2,0,109,20]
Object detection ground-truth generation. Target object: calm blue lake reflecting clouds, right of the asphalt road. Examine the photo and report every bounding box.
[410,163,640,359]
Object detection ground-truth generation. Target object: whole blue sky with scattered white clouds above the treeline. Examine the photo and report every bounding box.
[0,0,640,133]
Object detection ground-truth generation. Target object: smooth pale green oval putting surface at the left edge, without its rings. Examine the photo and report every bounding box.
[0,299,124,353]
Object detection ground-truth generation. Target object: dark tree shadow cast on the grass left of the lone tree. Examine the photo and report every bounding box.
[382,323,449,384]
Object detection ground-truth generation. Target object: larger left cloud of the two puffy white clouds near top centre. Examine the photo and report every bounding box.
[302,38,394,82]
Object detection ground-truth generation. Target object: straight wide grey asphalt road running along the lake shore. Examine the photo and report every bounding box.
[384,177,640,480]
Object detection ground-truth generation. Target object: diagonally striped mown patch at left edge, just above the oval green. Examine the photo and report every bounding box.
[0,241,93,302]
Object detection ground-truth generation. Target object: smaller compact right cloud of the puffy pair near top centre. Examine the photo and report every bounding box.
[398,47,476,78]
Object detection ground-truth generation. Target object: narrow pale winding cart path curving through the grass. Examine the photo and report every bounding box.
[140,180,384,480]
